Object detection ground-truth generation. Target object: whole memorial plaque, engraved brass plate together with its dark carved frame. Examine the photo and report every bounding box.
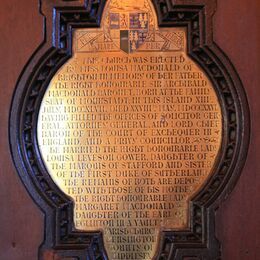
[9,0,250,260]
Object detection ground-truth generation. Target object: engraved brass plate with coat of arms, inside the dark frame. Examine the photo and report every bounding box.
[37,0,222,259]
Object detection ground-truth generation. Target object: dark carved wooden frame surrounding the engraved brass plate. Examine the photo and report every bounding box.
[10,0,250,260]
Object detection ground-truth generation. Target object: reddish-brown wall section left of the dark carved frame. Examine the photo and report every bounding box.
[0,0,44,260]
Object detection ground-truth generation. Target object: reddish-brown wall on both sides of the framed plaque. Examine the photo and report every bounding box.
[0,0,260,260]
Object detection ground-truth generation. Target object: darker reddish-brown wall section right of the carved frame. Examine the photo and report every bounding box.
[214,0,260,260]
